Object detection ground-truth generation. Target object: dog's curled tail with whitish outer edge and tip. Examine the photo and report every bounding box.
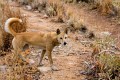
[4,18,22,36]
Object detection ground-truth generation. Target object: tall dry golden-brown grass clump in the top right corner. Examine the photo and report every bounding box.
[87,0,118,16]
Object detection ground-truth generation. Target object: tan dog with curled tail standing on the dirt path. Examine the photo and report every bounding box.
[5,18,67,70]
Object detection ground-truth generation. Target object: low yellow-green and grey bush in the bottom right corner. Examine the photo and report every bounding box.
[84,53,120,80]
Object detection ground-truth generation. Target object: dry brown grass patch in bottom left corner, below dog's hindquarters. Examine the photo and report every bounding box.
[0,53,40,80]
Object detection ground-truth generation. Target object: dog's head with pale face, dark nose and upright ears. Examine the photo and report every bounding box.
[56,29,68,46]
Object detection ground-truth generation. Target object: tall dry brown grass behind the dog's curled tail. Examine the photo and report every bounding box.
[0,2,27,51]
